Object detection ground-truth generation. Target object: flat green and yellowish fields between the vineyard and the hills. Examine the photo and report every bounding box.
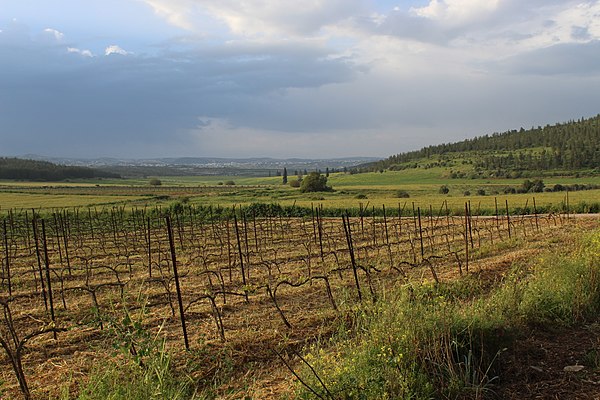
[0,168,600,212]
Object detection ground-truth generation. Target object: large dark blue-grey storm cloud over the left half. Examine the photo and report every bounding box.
[0,24,354,156]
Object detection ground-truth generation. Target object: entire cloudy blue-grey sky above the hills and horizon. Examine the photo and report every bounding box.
[0,0,600,158]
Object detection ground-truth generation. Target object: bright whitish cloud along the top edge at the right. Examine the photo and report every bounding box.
[354,0,600,50]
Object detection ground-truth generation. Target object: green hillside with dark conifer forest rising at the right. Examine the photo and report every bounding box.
[371,115,600,171]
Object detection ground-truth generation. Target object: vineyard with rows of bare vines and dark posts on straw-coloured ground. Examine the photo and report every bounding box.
[0,203,584,399]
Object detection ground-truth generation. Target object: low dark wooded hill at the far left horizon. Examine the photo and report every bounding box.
[0,157,121,181]
